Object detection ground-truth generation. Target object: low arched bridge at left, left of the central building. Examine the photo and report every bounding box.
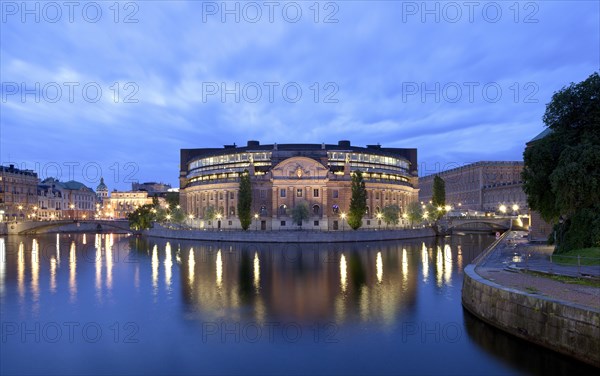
[7,219,132,235]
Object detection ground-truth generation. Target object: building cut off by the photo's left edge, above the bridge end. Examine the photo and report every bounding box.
[0,165,39,221]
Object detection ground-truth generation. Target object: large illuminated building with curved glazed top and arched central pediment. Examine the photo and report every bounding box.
[180,141,418,230]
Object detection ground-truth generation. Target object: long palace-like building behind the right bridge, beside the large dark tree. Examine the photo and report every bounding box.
[419,161,527,213]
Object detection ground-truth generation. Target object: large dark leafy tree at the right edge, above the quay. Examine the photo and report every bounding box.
[522,72,600,252]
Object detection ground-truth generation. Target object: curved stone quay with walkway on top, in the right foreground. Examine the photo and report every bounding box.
[462,232,600,367]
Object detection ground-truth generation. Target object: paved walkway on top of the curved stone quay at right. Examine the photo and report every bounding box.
[475,231,600,309]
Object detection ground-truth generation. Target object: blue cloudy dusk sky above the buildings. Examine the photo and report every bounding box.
[0,0,600,190]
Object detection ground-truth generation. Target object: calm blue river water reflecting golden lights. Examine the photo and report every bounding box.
[0,233,591,374]
